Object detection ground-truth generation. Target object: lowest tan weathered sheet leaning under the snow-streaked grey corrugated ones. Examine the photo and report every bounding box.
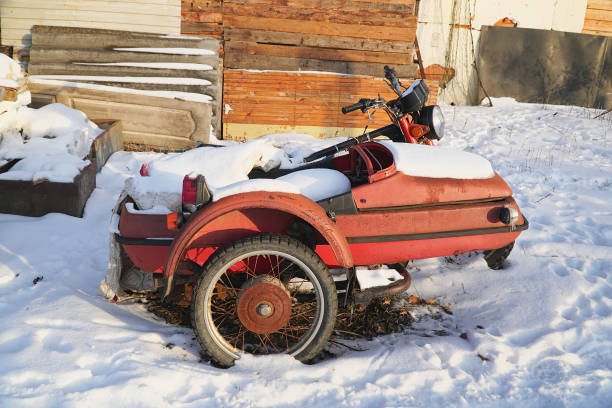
[28,80,212,151]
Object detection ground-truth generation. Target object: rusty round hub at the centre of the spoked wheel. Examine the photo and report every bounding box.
[236,275,291,334]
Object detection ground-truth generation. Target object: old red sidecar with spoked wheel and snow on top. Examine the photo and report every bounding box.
[105,142,528,366]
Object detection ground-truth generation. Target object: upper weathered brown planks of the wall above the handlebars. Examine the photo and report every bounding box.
[223,0,418,77]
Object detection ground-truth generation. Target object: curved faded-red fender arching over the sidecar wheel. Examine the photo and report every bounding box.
[163,191,353,282]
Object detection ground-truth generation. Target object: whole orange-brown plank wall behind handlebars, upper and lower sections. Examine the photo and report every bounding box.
[222,0,437,140]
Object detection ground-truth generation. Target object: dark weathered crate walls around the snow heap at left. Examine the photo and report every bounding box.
[0,120,122,217]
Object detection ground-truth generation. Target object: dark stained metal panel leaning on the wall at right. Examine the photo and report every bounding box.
[478,26,612,109]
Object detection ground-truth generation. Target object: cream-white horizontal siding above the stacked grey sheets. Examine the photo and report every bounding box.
[0,0,181,47]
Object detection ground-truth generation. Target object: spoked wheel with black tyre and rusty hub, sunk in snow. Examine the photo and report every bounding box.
[191,234,338,366]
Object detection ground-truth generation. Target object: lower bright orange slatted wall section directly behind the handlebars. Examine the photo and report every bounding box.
[223,70,438,139]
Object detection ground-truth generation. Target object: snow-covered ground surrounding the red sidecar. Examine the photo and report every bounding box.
[0,99,612,407]
